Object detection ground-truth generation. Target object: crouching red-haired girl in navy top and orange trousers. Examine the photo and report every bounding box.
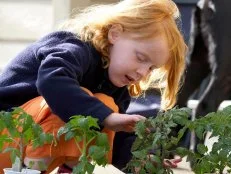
[0,0,186,170]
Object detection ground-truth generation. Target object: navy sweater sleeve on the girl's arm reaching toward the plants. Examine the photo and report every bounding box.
[36,32,113,124]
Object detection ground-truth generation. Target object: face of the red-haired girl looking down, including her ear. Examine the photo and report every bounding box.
[108,27,169,87]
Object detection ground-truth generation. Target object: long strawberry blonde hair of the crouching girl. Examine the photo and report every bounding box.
[59,0,187,110]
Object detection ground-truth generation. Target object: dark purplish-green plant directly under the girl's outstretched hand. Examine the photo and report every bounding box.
[126,108,191,174]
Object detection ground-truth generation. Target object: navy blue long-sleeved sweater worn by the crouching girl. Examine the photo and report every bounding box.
[0,31,130,123]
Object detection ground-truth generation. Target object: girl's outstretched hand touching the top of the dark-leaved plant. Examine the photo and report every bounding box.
[103,113,145,132]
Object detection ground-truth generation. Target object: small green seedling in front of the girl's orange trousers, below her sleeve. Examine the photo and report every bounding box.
[57,115,110,174]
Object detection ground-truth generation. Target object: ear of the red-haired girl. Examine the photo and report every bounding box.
[108,24,123,44]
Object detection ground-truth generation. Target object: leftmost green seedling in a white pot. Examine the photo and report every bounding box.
[0,107,53,174]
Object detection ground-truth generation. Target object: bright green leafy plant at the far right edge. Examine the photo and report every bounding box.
[177,106,231,174]
